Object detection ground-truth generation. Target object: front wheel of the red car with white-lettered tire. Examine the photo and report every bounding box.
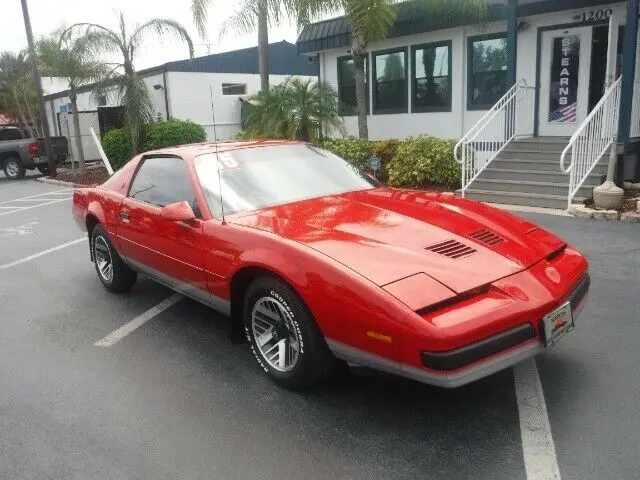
[243,277,334,390]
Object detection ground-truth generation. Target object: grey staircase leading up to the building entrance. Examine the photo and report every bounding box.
[466,137,608,210]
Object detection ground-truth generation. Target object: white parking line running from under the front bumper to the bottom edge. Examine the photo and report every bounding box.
[513,358,560,480]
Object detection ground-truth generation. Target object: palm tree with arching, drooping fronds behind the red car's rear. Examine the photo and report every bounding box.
[61,12,193,153]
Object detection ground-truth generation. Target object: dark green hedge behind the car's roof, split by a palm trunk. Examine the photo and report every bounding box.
[102,118,207,170]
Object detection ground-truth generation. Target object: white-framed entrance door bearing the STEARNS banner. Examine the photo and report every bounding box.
[538,27,593,137]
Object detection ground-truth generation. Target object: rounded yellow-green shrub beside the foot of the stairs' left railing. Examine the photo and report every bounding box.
[387,135,460,188]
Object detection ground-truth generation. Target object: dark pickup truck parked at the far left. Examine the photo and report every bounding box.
[0,127,69,180]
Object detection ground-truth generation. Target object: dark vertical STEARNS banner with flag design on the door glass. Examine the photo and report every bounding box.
[549,35,580,123]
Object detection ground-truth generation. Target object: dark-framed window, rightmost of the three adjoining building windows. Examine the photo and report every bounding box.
[411,41,451,112]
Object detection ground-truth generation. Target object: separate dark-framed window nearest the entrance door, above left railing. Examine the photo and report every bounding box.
[467,33,508,110]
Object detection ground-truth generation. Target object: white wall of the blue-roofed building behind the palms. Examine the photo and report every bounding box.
[167,72,315,140]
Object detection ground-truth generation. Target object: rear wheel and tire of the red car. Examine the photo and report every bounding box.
[91,225,138,293]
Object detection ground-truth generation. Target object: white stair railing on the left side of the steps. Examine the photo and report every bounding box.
[454,80,535,197]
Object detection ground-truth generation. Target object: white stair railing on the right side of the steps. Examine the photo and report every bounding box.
[560,77,622,208]
